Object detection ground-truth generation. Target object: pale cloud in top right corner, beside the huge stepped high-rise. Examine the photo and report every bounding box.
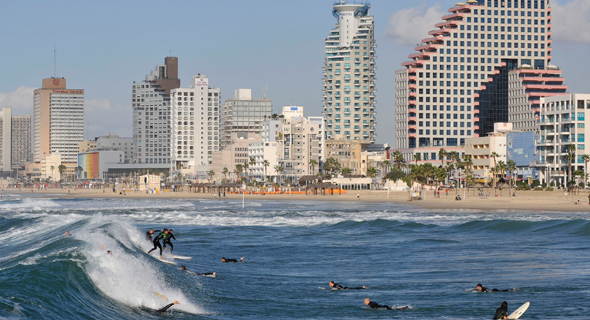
[551,0,590,43]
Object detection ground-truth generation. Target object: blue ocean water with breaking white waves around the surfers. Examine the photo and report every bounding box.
[0,195,590,319]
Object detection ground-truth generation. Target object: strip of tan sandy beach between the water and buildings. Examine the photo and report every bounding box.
[4,188,590,212]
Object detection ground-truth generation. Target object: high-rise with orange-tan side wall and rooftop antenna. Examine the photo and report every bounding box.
[33,78,84,166]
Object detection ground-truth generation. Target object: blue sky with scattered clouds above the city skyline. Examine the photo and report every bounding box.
[0,0,590,145]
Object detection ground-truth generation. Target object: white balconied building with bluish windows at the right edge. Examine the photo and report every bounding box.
[536,94,590,185]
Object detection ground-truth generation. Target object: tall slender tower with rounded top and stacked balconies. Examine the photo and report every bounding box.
[322,0,377,147]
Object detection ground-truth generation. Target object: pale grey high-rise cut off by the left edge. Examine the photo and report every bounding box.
[0,107,31,171]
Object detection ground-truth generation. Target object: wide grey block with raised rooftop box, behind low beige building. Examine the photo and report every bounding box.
[220,89,272,148]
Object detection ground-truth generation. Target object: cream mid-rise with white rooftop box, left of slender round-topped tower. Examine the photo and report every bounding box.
[277,106,326,181]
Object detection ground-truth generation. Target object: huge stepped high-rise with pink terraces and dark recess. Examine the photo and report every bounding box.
[396,0,565,162]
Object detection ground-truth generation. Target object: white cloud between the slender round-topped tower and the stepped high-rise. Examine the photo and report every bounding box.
[385,4,448,46]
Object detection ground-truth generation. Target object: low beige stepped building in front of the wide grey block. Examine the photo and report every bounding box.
[210,133,262,180]
